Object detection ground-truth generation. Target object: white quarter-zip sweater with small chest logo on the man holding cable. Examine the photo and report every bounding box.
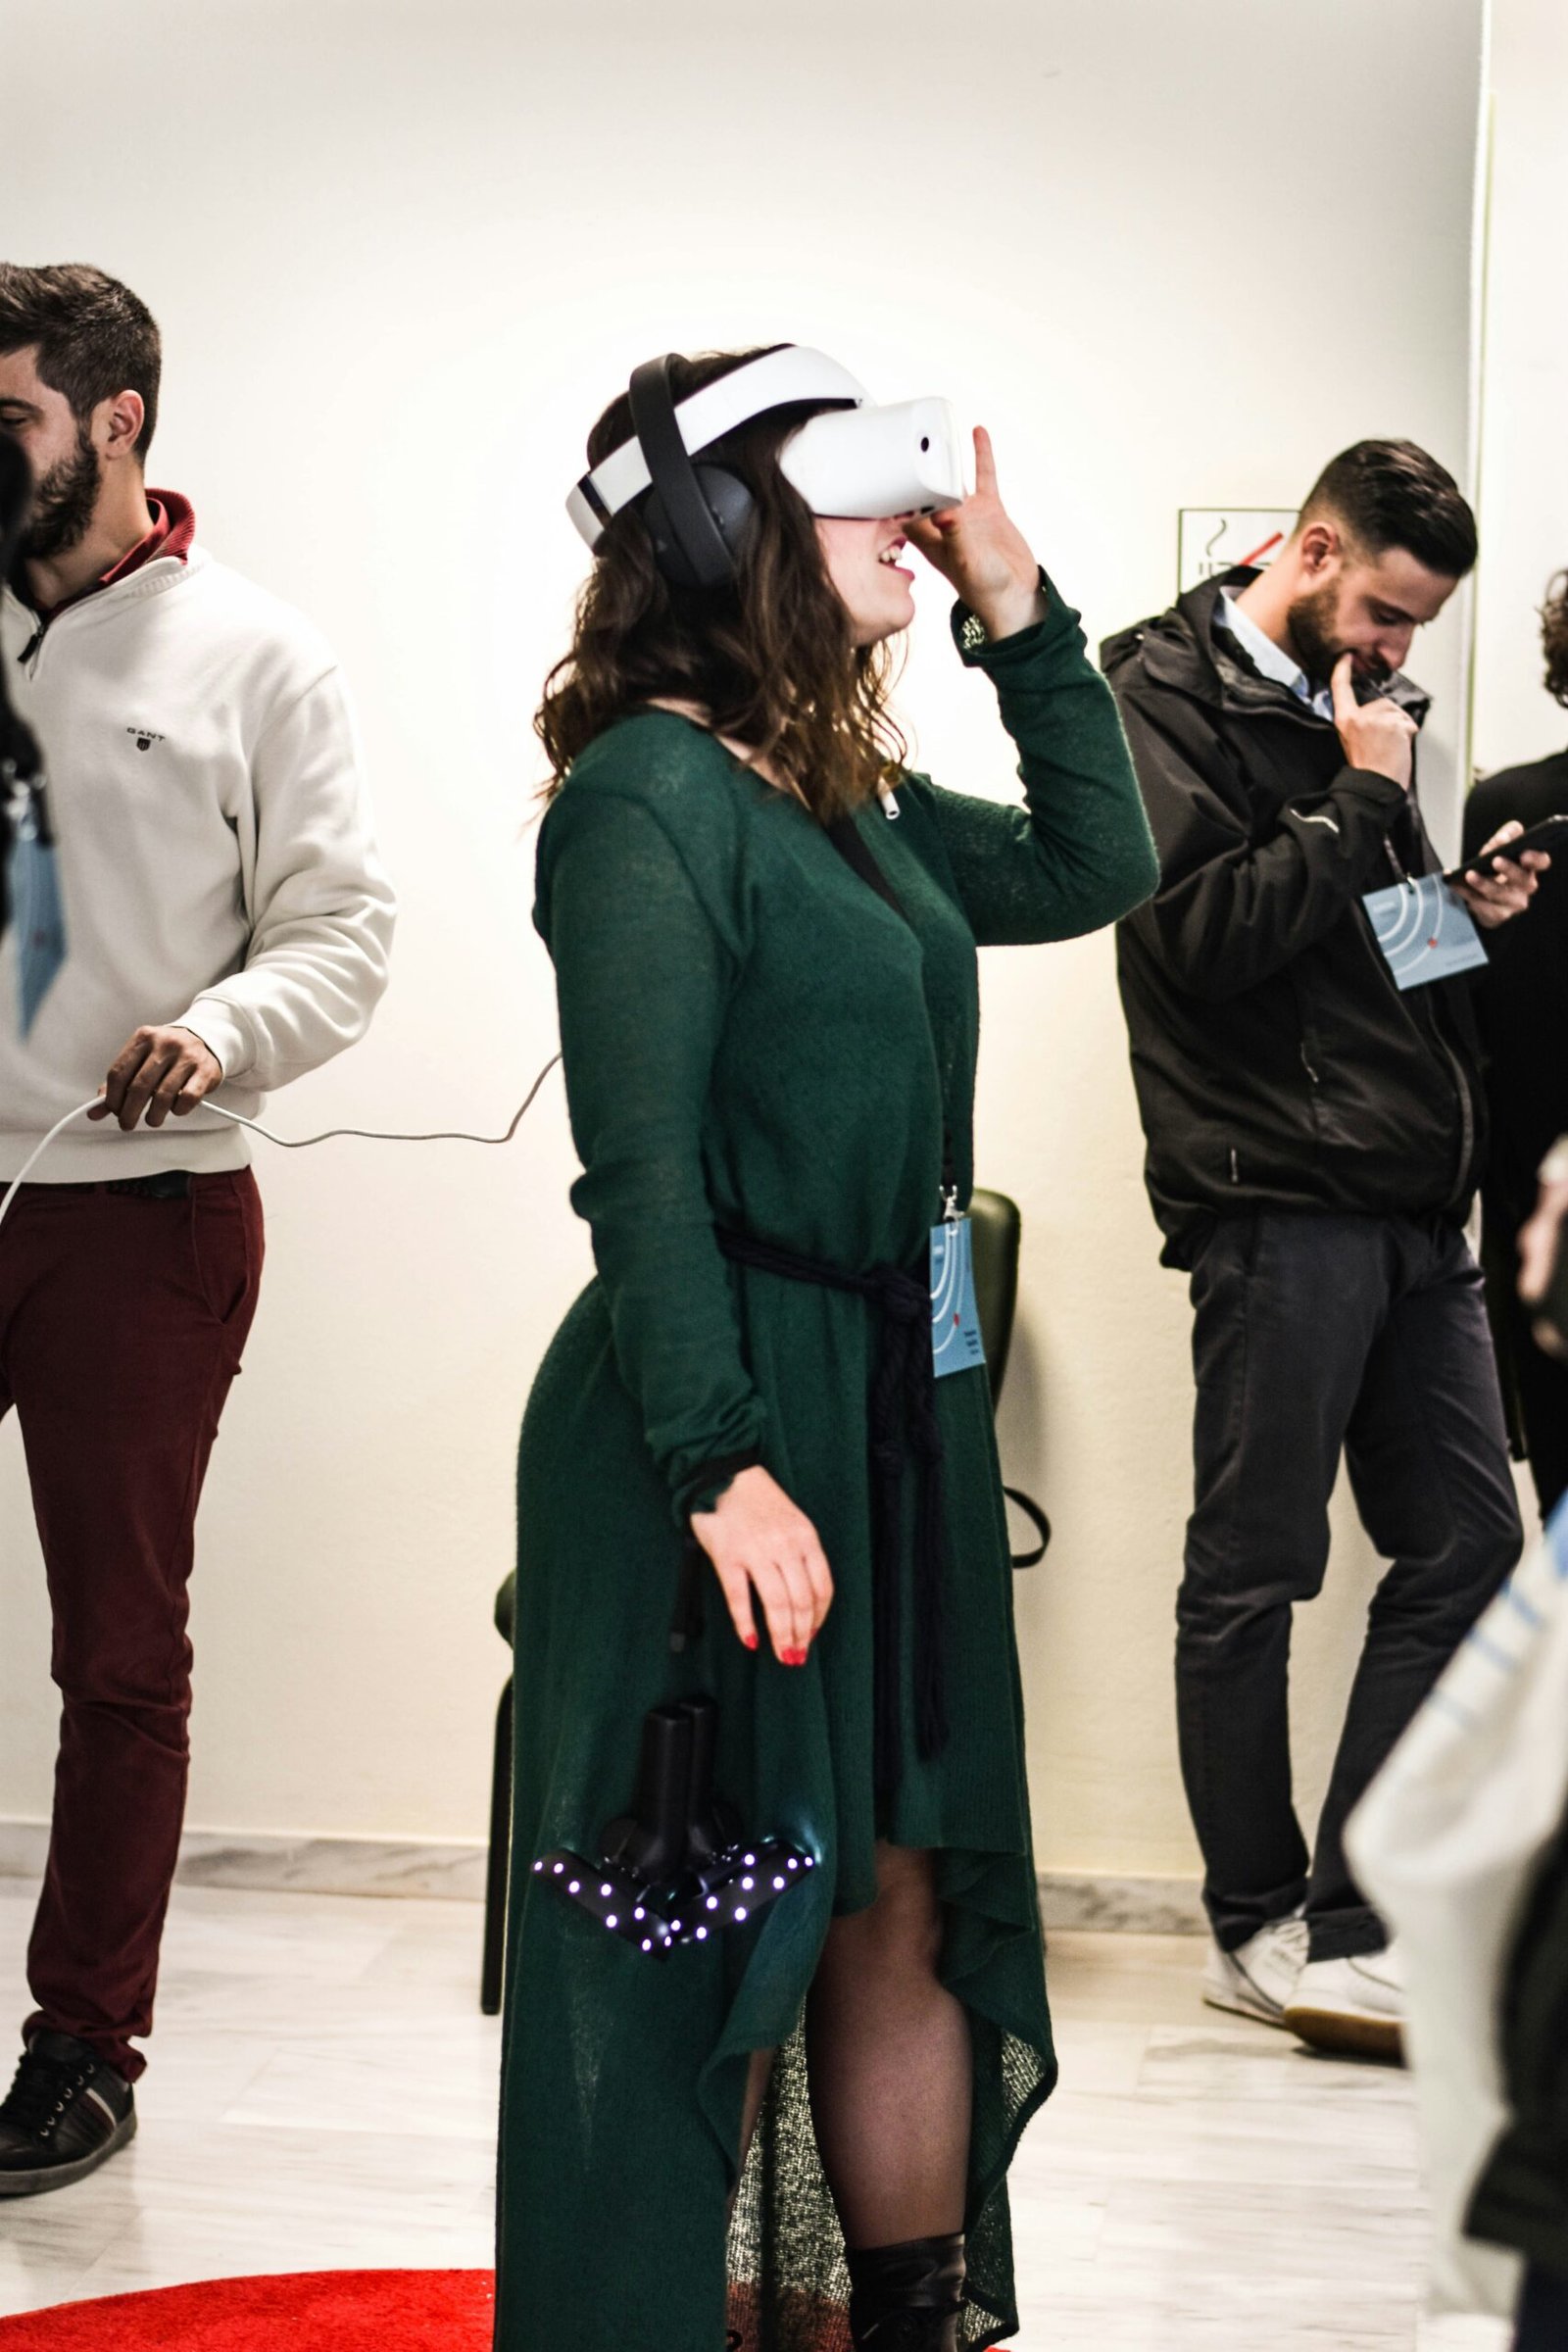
[0,546,395,1183]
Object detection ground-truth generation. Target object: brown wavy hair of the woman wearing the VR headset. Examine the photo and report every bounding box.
[534,346,906,823]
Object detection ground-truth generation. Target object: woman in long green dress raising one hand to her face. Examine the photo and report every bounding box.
[496,353,1156,2352]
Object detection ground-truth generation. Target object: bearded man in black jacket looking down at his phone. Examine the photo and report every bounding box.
[1102,442,1535,2053]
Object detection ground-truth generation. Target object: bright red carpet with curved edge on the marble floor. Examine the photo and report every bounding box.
[0,2270,496,2352]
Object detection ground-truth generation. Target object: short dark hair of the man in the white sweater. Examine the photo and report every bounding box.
[0,261,163,457]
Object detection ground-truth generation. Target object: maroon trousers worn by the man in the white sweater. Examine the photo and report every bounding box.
[0,1169,261,2082]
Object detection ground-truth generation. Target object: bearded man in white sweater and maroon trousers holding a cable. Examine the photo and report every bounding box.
[0,264,393,2194]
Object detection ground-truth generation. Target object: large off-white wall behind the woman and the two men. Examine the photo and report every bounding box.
[0,0,1481,1872]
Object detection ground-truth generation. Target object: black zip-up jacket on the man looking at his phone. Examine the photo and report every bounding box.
[1101,571,1486,1265]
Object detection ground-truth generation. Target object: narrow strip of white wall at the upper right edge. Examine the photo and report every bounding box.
[1474,0,1568,769]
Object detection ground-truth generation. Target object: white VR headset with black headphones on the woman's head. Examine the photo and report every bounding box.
[566,343,968,586]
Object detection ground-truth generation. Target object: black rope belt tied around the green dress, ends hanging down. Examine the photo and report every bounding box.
[719,1230,948,1801]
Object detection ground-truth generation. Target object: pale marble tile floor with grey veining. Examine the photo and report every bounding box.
[0,1880,1507,2352]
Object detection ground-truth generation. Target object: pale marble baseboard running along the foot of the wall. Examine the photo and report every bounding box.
[0,1821,1203,1936]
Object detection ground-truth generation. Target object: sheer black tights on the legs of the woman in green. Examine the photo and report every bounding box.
[743,1844,973,2248]
